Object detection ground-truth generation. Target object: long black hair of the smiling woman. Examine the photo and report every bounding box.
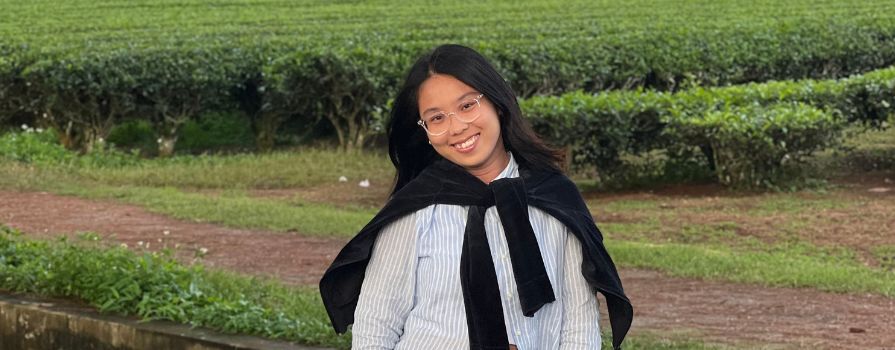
[388,44,561,194]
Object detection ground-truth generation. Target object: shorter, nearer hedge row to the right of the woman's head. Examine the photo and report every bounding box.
[522,68,895,187]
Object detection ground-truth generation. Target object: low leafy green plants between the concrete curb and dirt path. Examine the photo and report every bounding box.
[0,227,350,348]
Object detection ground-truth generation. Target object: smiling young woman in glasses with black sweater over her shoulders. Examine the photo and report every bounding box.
[320,45,633,350]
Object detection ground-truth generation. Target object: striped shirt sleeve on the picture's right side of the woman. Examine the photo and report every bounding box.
[560,225,601,350]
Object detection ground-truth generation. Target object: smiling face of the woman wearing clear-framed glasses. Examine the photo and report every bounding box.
[418,74,509,175]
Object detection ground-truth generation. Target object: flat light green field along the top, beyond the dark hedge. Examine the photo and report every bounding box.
[0,0,895,47]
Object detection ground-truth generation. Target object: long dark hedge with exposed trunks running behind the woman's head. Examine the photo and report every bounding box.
[0,2,895,155]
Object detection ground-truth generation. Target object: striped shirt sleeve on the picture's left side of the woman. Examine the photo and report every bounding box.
[351,214,417,349]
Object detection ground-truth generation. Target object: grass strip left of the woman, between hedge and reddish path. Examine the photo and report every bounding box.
[0,163,376,237]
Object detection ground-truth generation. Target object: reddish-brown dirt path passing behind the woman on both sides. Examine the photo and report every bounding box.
[0,191,895,349]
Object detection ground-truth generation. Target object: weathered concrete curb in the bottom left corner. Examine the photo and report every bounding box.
[0,292,331,350]
